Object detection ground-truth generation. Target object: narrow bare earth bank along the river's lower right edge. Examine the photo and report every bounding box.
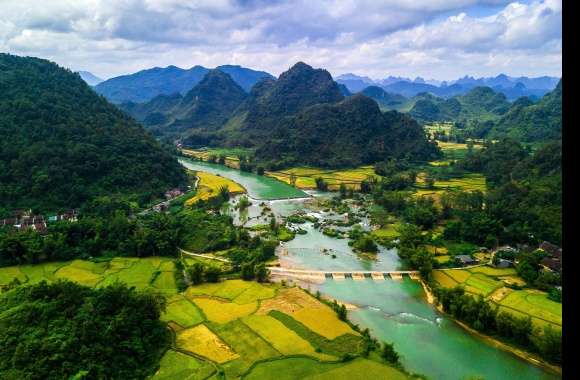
[421,280,562,376]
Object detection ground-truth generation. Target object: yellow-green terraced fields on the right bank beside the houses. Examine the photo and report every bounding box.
[433,266,562,328]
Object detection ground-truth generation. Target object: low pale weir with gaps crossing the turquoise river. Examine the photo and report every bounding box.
[268,267,420,281]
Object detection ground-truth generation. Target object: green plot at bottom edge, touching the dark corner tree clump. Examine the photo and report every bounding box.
[152,350,215,380]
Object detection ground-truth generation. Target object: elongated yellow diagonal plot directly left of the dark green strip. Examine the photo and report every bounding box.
[242,315,336,360]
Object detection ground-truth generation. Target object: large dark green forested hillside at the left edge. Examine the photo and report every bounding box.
[0,54,185,210]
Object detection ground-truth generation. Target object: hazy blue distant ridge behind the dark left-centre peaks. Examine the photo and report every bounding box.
[95,65,273,104]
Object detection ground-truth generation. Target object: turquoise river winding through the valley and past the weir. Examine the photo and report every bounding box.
[180,159,561,380]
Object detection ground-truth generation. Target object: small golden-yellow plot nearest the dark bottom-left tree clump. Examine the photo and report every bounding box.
[176,324,240,363]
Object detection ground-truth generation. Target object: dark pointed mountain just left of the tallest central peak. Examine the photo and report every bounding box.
[120,69,247,136]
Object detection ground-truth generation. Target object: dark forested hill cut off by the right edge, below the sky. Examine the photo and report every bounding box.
[488,79,562,142]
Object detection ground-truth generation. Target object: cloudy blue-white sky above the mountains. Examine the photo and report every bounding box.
[0,0,562,80]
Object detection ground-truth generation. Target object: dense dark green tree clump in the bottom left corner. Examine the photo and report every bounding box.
[0,281,170,379]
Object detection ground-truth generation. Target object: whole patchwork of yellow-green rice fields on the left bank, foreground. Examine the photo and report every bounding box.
[0,257,408,380]
